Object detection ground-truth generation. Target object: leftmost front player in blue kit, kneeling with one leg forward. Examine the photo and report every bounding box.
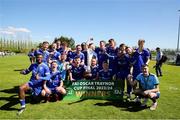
[18,54,50,115]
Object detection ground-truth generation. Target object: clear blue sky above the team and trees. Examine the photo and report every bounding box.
[0,0,180,49]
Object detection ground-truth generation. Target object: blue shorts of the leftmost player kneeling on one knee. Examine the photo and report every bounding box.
[28,81,42,96]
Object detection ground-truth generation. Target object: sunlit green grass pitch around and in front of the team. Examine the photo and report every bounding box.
[0,55,180,119]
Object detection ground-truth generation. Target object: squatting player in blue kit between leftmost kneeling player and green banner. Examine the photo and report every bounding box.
[42,61,66,100]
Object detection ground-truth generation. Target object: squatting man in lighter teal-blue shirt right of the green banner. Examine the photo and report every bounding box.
[128,65,160,110]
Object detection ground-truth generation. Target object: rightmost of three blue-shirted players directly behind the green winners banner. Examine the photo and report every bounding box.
[99,61,114,80]
